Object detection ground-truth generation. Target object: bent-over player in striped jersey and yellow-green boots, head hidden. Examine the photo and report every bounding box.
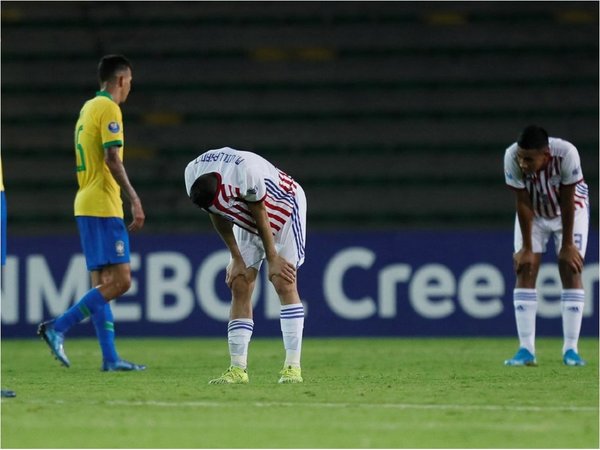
[185,147,306,384]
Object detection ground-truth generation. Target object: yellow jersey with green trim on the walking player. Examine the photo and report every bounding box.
[75,91,124,218]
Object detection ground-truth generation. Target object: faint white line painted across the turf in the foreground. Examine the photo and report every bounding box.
[11,399,600,413]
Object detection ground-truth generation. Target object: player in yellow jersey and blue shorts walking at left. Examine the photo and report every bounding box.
[38,55,146,371]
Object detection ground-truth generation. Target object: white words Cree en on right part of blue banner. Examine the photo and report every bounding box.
[323,247,599,320]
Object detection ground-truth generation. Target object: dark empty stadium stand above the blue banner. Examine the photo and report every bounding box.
[1,1,599,235]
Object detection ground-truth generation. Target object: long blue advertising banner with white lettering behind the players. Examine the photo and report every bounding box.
[1,231,599,338]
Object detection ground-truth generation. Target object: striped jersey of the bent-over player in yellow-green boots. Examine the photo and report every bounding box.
[185,147,298,234]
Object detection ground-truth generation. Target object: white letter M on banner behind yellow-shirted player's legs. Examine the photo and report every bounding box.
[26,254,89,323]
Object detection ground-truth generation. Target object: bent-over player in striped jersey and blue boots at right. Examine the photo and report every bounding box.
[504,125,589,366]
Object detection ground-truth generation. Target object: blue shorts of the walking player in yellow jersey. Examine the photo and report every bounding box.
[75,216,130,272]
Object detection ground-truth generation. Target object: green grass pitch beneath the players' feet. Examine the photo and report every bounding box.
[1,338,599,448]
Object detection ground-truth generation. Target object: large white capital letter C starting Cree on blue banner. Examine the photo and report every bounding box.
[323,247,377,320]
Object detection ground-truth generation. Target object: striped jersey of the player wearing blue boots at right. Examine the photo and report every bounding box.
[504,138,589,219]
